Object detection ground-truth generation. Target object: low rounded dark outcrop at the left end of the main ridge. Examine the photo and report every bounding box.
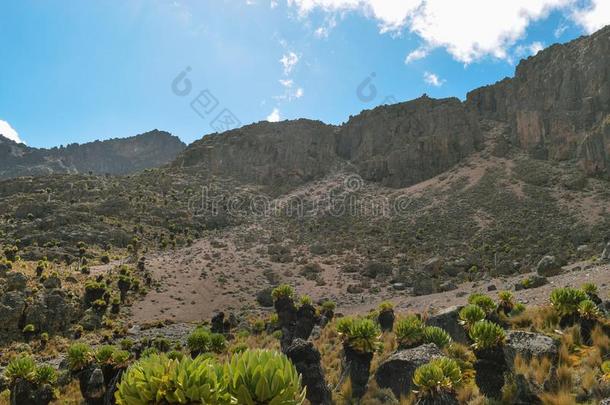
[173,119,338,185]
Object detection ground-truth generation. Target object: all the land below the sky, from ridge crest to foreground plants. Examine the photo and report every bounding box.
[0,27,610,405]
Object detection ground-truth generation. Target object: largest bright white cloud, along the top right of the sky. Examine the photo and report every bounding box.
[288,0,610,63]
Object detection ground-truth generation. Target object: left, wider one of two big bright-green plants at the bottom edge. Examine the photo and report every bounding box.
[115,355,235,405]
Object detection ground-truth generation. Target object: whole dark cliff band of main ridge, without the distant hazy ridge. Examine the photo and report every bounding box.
[173,27,610,188]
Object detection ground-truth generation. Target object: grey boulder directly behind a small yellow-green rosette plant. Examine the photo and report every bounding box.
[375,343,443,398]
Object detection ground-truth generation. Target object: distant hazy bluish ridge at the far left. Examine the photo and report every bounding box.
[0,130,185,179]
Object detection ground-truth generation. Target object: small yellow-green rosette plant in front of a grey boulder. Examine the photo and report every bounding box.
[413,357,462,395]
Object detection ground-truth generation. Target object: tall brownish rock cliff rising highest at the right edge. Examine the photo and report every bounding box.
[466,27,610,174]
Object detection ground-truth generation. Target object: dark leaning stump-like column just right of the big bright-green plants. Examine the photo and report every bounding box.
[285,339,332,405]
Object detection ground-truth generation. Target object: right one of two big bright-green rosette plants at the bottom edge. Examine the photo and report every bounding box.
[224,350,305,405]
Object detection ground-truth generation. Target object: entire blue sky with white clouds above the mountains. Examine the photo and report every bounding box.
[0,0,610,147]
